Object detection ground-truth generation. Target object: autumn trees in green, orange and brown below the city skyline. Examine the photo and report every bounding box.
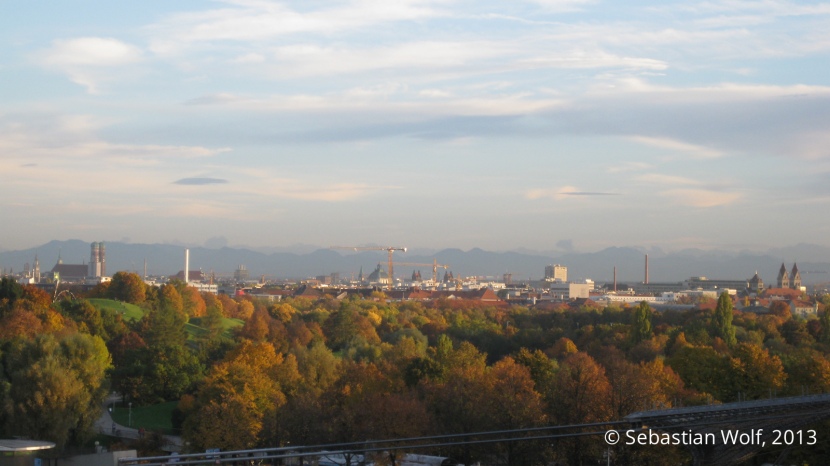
[0,273,830,465]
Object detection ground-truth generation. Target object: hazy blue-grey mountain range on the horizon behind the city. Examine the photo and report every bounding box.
[0,240,830,284]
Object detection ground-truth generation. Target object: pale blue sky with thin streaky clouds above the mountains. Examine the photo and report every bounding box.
[0,0,830,255]
